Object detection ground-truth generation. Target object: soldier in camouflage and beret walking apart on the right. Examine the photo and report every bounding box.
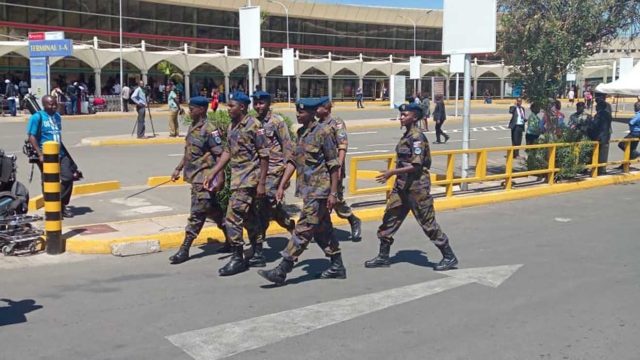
[364,104,458,271]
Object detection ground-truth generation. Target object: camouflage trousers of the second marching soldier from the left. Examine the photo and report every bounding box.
[225,188,261,246]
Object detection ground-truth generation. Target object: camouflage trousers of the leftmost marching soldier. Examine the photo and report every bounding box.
[185,183,224,243]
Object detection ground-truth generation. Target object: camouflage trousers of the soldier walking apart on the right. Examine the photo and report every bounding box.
[378,189,449,247]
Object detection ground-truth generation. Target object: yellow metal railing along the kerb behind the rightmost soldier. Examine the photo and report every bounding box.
[349,138,640,197]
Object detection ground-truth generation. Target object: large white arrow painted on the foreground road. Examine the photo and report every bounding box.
[167,264,522,360]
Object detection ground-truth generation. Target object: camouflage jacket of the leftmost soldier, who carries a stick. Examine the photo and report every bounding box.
[183,120,227,184]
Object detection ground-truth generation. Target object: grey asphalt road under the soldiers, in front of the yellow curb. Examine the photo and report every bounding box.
[0,184,640,360]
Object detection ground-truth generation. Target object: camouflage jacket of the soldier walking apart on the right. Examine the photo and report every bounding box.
[393,126,431,191]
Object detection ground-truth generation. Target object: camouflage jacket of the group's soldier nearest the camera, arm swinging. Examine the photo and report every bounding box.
[294,121,339,199]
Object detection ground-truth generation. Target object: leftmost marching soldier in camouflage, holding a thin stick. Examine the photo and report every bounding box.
[169,96,226,264]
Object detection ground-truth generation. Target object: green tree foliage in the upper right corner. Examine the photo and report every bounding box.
[498,0,640,109]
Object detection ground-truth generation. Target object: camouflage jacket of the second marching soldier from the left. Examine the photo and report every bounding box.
[227,115,269,190]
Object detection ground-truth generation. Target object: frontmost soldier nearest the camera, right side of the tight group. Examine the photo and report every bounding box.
[258,99,347,285]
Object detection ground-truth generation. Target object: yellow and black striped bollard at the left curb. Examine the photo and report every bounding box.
[42,141,64,255]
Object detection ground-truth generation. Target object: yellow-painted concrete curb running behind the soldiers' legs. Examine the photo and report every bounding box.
[66,172,640,254]
